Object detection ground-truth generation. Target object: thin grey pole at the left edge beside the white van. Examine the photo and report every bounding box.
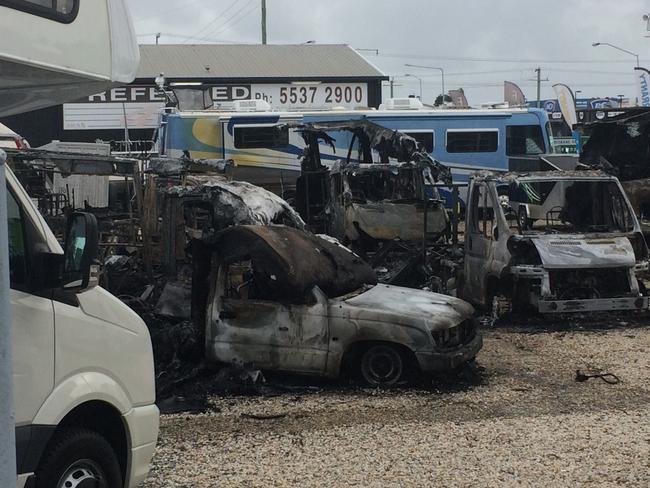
[0,149,16,486]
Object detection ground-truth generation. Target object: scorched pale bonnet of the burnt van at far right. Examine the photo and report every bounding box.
[531,234,636,268]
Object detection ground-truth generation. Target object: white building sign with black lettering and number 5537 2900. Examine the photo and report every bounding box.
[63,82,368,130]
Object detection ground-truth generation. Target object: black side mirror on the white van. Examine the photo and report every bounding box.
[63,212,99,291]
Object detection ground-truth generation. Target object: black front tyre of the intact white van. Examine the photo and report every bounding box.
[36,428,124,488]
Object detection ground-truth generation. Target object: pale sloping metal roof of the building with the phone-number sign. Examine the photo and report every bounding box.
[137,44,388,80]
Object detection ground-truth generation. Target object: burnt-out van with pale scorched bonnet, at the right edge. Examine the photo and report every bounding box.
[460,170,648,313]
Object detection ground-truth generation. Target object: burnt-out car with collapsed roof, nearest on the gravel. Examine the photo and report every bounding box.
[204,225,482,386]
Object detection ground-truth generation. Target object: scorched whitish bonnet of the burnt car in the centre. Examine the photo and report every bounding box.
[345,285,474,329]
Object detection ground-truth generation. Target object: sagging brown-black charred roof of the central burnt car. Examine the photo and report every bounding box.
[206,225,377,301]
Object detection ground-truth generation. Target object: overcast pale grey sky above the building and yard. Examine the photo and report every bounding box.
[129,0,650,105]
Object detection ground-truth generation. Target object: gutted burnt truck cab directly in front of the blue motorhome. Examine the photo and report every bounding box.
[293,118,451,249]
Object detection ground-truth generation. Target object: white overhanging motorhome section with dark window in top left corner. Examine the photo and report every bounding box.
[0,0,140,116]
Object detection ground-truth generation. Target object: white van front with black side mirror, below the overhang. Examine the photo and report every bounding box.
[0,156,158,488]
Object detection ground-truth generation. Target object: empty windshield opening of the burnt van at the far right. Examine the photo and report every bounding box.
[498,179,634,233]
